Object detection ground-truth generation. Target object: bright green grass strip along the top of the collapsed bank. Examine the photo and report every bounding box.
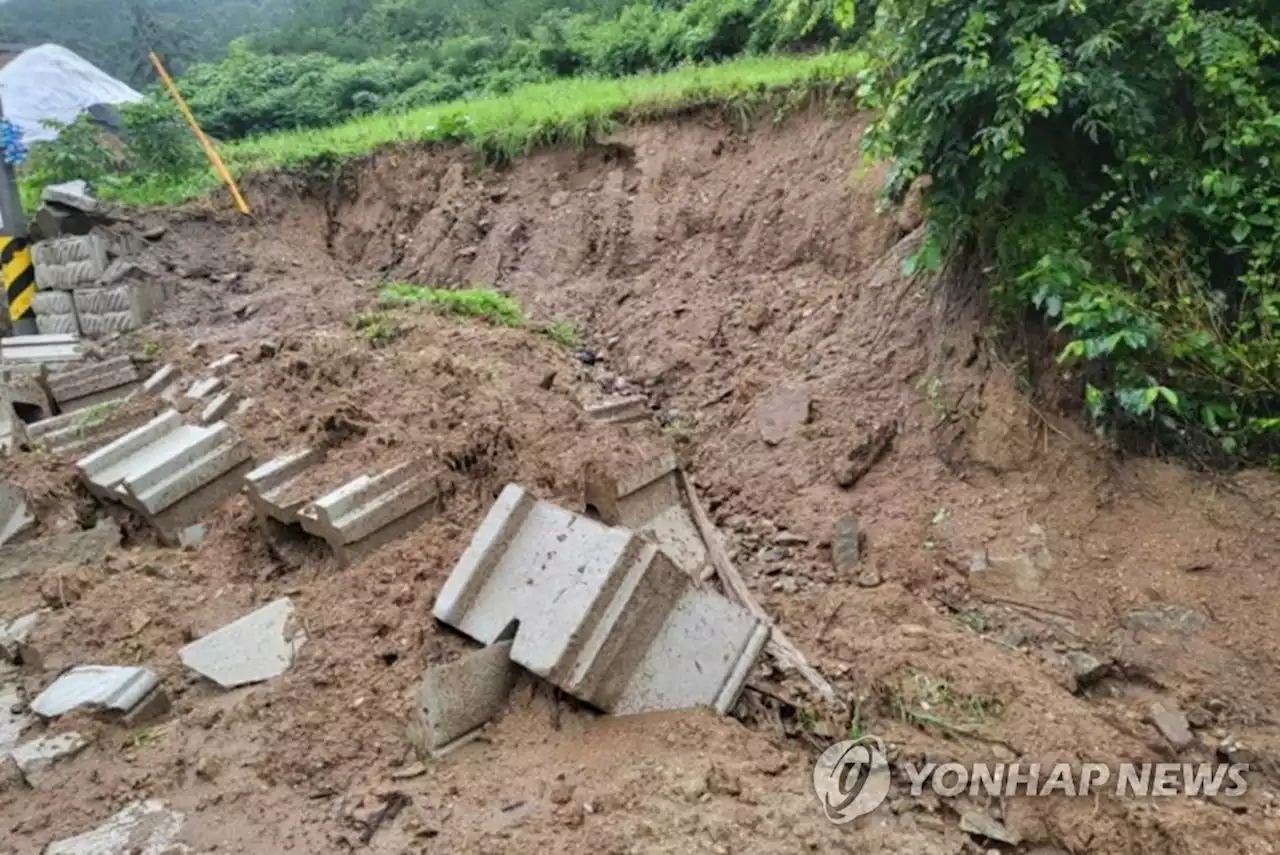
[82,51,867,205]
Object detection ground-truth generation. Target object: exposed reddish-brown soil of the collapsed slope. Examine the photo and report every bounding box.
[0,108,1280,855]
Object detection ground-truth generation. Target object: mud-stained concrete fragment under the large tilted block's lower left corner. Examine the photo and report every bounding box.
[410,641,518,760]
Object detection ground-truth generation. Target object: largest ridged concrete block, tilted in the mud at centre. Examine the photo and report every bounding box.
[435,485,768,714]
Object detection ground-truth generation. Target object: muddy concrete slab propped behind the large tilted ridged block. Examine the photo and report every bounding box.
[582,453,707,579]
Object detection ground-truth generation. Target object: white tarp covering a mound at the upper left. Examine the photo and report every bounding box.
[0,45,142,145]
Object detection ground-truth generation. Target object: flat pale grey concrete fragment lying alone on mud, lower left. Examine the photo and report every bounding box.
[179,598,307,689]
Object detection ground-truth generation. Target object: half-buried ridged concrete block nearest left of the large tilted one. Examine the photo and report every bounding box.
[297,462,445,564]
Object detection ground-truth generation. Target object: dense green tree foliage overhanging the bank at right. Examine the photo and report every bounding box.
[849,0,1280,457]
